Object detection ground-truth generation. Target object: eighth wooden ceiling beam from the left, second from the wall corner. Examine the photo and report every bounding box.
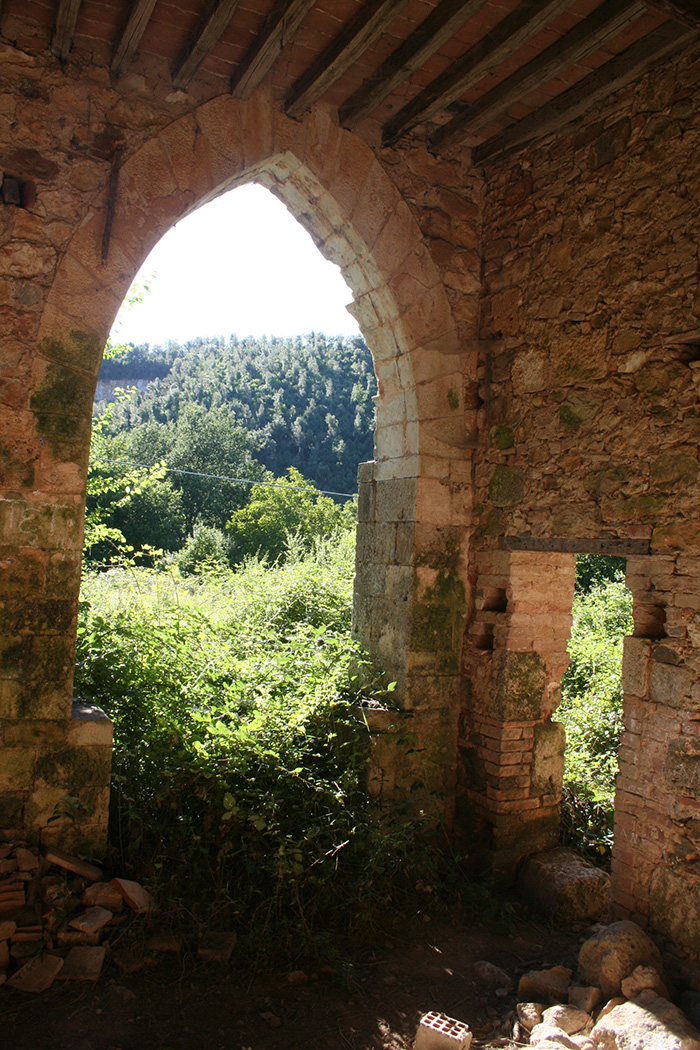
[429,0,645,150]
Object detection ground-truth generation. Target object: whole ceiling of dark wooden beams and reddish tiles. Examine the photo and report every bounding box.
[0,0,700,165]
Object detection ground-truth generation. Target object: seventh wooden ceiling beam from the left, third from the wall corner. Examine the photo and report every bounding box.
[382,0,571,146]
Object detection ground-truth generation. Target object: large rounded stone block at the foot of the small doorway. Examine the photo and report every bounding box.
[518,849,608,923]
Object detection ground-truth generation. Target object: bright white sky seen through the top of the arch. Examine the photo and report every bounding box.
[114,186,360,345]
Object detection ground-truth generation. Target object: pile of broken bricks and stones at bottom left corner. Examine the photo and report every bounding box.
[0,833,236,994]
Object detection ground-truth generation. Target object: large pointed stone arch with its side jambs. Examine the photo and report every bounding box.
[7,96,471,847]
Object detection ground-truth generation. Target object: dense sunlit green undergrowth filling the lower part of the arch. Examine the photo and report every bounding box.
[76,539,474,961]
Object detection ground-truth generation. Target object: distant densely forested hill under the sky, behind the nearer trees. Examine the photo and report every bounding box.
[100,334,376,492]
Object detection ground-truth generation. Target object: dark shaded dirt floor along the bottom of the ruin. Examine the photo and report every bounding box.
[0,921,585,1050]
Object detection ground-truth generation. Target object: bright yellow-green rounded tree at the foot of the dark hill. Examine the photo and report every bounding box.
[226,466,352,562]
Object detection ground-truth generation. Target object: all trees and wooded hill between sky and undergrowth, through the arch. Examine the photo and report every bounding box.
[86,334,376,571]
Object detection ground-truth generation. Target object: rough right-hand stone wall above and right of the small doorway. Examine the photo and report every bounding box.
[470,49,700,962]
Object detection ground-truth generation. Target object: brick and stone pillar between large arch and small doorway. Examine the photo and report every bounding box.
[458,551,575,881]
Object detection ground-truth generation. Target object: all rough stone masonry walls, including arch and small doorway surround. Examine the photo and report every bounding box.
[0,4,700,982]
